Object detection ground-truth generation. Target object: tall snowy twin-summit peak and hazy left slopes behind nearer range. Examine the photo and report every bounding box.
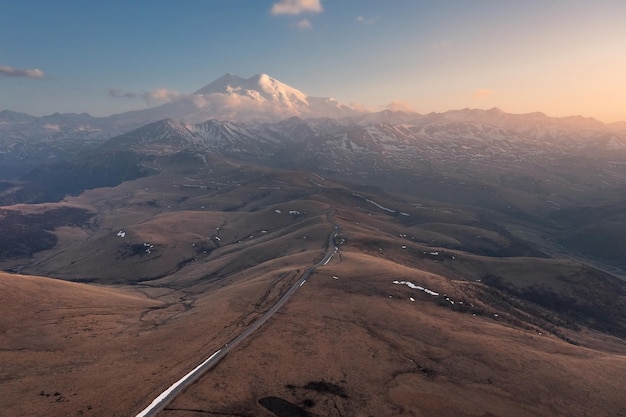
[0,74,358,177]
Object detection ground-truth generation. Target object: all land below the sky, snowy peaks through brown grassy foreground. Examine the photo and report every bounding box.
[0,74,626,417]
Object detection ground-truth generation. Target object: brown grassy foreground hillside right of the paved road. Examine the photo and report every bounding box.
[161,252,626,417]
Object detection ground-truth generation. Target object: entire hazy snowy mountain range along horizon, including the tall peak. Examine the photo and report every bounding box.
[0,74,626,193]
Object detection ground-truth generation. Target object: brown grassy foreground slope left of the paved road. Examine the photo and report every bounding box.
[0,258,316,417]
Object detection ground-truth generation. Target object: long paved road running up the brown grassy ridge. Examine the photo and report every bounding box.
[136,208,341,417]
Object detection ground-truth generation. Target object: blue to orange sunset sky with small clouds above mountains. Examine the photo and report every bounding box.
[0,0,626,122]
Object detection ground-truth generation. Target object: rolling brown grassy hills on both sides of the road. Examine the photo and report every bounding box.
[0,161,626,417]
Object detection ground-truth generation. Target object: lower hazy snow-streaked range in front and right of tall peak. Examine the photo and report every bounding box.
[95,110,626,184]
